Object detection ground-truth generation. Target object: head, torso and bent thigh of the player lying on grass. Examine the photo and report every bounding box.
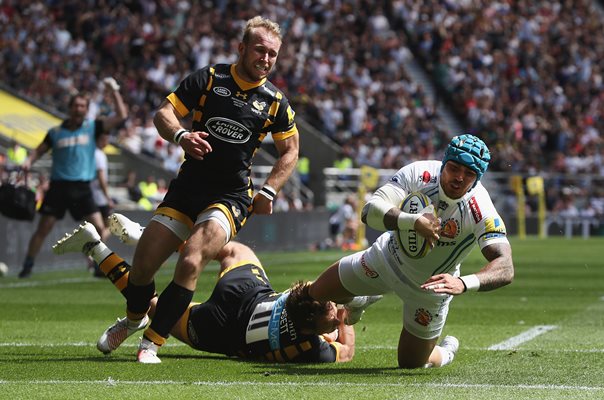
[165,242,355,363]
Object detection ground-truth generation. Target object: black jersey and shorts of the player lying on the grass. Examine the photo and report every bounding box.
[187,263,339,363]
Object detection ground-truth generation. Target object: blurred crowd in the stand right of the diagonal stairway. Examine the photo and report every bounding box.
[395,0,604,175]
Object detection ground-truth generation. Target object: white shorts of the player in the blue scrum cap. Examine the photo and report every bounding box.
[338,252,453,339]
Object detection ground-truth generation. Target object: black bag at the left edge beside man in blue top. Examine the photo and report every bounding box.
[0,175,36,221]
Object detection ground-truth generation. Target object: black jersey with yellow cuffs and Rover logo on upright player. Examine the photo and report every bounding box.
[167,64,298,191]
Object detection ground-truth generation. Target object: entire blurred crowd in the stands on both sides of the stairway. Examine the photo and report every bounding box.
[0,0,604,216]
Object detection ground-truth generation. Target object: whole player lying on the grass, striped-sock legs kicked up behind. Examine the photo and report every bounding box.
[53,214,381,363]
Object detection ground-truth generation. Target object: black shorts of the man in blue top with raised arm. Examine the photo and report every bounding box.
[40,181,99,221]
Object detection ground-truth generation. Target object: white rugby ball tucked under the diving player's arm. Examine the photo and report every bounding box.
[397,192,434,259]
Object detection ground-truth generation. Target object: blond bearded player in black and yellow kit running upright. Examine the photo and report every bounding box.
[106,16,299,363]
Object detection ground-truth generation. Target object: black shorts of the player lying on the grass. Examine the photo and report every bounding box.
[187,264,275,355]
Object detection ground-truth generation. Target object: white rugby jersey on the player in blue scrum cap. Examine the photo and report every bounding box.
[364,160,508,287]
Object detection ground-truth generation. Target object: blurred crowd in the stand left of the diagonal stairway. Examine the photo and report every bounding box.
[0,0,447,168]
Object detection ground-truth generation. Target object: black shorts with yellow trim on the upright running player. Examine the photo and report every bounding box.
[158,178,253,236]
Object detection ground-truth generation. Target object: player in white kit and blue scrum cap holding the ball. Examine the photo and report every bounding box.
[310,134,514,368]
